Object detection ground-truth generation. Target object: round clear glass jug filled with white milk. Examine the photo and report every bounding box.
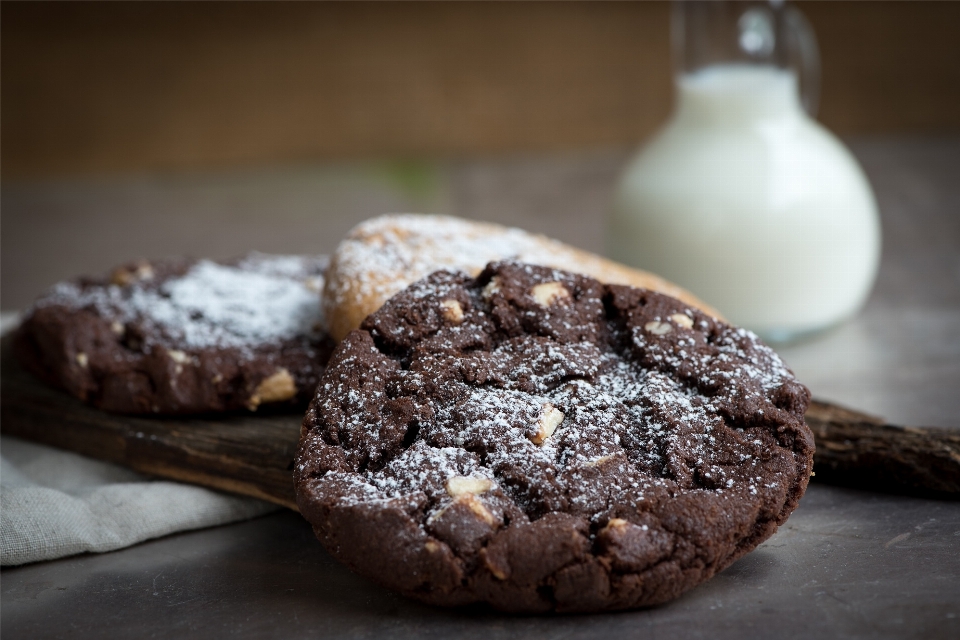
[607,2,880,342]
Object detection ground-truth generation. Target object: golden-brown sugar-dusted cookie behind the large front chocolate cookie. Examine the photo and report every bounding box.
[323,214,719,341]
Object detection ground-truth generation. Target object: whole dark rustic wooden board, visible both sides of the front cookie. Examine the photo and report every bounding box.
[0,338,960,509]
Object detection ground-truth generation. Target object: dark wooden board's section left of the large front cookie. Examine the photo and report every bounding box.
[0,338,301,509]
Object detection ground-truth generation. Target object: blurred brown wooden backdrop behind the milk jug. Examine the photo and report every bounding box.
[0,2,960,179]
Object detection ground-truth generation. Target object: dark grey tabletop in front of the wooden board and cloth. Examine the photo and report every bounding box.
[0,486,960,640]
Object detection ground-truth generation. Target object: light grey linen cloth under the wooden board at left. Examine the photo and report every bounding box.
[0,314,280,566]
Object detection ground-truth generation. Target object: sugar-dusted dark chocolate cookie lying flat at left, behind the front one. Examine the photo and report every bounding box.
[14,253,333,414]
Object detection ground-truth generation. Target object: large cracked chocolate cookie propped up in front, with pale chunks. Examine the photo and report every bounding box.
[295,263,813,611]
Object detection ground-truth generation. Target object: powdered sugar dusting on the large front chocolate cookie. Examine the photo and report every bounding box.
[302,258,802,522]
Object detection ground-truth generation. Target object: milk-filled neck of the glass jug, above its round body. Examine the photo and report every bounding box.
[675,63,805,124]
